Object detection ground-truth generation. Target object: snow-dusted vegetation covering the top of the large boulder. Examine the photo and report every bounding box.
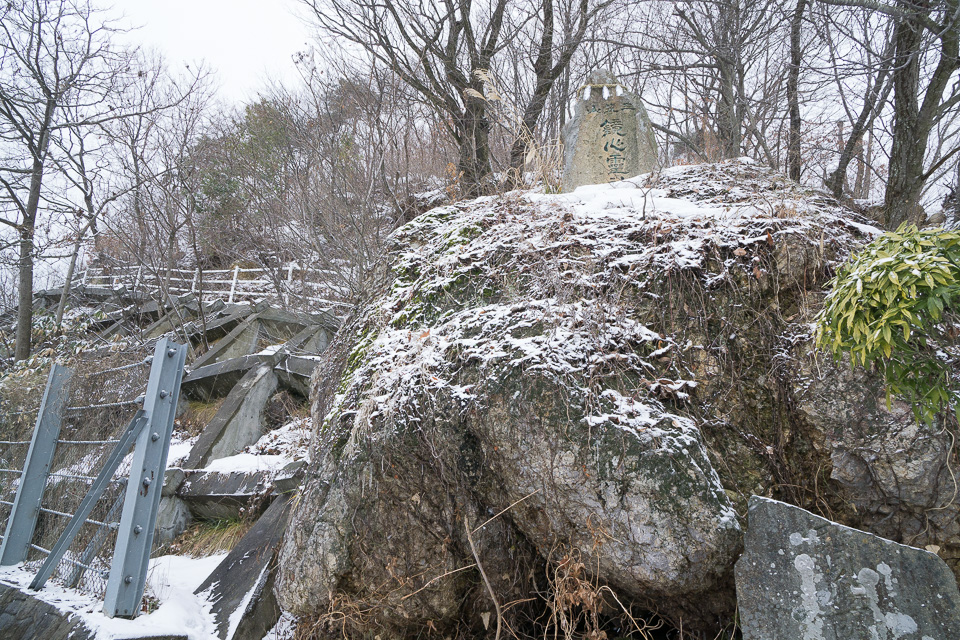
[335,158,880,450]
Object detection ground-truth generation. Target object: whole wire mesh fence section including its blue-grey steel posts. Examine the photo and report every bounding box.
[0,337,187,617]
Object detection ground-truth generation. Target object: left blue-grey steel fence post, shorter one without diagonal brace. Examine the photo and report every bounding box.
[0,364,73,566]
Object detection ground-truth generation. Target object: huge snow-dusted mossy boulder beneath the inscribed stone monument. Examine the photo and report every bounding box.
[277,160,957,640]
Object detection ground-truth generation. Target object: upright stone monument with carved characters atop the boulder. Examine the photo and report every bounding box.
[563,71,657,192]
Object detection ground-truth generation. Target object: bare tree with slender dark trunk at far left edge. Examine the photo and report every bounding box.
[0,0,127,359]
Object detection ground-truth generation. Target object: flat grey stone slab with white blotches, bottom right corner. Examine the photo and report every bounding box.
[736,496,960,640]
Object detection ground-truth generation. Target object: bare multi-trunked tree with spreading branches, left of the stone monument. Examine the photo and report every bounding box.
[303,0,610,194]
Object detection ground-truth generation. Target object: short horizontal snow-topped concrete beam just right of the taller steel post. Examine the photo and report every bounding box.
[177,471,274,520]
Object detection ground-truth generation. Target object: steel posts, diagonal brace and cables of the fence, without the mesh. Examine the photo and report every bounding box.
[0,338,187,618]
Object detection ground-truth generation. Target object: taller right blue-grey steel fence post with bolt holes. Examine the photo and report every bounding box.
[103,338,187,618]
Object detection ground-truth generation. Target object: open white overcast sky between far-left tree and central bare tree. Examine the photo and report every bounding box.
[109,0,312,103]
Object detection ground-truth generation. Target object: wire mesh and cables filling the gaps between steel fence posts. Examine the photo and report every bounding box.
[0,345,164,598]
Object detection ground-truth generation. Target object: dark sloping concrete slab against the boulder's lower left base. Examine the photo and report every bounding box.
[195,494,292,640]
